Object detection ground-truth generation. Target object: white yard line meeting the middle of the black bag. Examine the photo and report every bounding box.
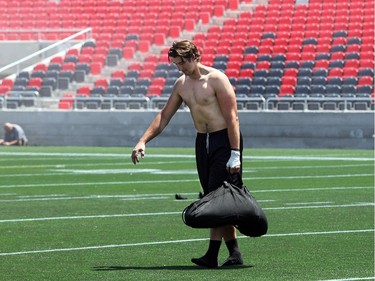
[0,202,375,223]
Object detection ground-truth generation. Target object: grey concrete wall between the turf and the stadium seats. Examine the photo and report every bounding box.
[0,110,374,149]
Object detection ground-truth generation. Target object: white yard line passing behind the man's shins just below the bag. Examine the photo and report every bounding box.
[0,229,374,256]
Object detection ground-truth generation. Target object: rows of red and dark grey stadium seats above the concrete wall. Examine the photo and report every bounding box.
[0,0,374,110]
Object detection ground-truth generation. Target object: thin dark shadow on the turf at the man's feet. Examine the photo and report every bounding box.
[92,265,253,271]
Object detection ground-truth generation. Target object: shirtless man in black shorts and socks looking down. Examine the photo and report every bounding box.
[131,40,243,268]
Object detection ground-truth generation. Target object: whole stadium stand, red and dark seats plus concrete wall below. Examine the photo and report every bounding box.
[0,0,375,148]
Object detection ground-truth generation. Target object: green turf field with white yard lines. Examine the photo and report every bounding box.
[0,147,375,281]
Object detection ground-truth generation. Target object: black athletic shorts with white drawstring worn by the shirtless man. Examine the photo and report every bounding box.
[195,129,243,194]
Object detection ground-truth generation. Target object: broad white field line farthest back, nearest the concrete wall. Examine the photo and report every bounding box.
[0,152,374,161]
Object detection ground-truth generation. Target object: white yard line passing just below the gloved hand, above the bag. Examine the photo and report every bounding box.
[0,174,374,188]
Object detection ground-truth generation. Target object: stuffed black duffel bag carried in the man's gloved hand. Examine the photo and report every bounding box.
[182,181,268,237]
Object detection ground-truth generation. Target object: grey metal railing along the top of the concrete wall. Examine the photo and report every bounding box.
[0,94,375,111]
